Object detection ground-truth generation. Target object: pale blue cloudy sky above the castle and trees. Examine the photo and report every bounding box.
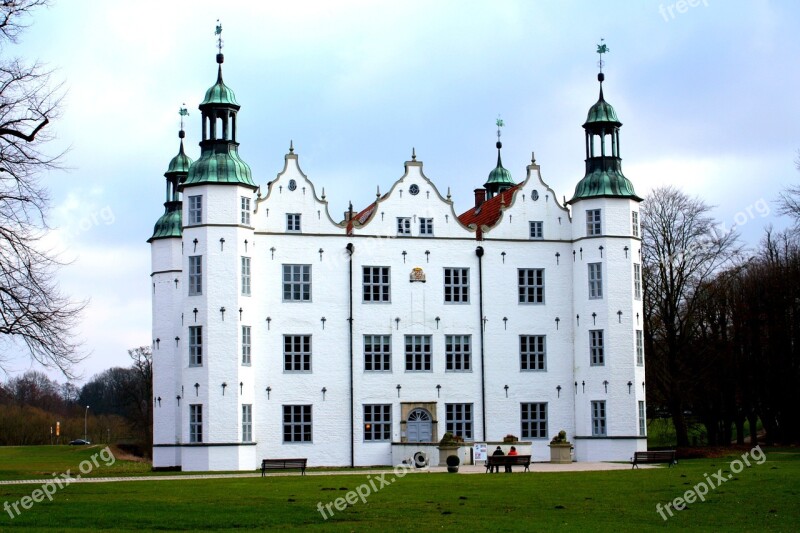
[3,0,800,381]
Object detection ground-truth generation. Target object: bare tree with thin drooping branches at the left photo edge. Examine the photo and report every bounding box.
[0,0,84,376]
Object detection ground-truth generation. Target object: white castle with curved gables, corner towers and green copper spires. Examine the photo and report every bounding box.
[148,45,647,470]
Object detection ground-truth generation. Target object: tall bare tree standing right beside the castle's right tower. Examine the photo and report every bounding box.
[642,186,740,446]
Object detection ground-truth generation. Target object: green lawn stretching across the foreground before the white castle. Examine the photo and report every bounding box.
[0,447,800,531]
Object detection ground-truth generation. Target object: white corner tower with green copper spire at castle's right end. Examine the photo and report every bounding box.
[568,44,647,461]
